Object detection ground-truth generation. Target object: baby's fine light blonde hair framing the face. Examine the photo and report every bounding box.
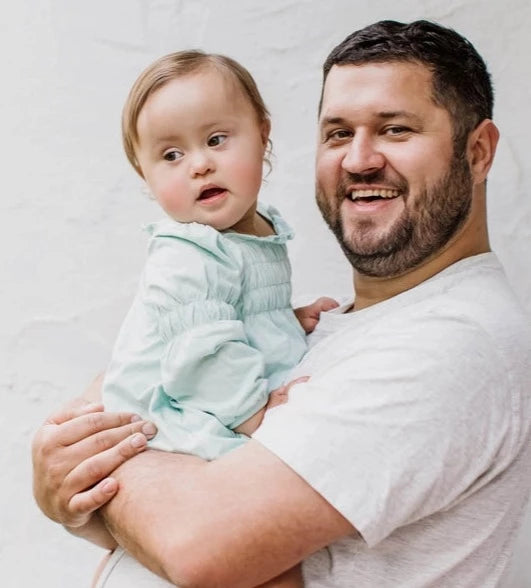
[122,50,271,177]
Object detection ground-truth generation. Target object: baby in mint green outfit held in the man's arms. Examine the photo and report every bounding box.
[103,51,336,460]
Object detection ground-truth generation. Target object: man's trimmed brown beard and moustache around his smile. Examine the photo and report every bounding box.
[316,149,472,278]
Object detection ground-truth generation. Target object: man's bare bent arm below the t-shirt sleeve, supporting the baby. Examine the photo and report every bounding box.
[103,441,354,588]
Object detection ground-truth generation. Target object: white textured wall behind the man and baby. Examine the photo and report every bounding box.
[0,0,531,588]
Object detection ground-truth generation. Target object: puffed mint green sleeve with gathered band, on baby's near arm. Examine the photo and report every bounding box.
[143,235,268,428]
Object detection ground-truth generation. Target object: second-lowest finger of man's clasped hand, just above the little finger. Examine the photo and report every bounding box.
[65,433,152,496]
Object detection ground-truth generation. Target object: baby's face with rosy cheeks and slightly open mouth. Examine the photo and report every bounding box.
[136,69,269,232]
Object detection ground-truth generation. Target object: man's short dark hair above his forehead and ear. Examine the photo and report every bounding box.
[319,20,494,145]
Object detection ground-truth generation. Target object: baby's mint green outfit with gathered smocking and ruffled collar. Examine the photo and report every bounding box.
[103,207,306,459]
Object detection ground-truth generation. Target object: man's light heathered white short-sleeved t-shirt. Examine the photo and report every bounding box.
[254,253,531,588]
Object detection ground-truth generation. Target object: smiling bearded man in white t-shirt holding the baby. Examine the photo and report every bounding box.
[34,21,531,588]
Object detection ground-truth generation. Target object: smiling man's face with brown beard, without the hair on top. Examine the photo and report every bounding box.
[317,61,474,278]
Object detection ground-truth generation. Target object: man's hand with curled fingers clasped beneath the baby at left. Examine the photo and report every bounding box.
[32,401,155,546]
